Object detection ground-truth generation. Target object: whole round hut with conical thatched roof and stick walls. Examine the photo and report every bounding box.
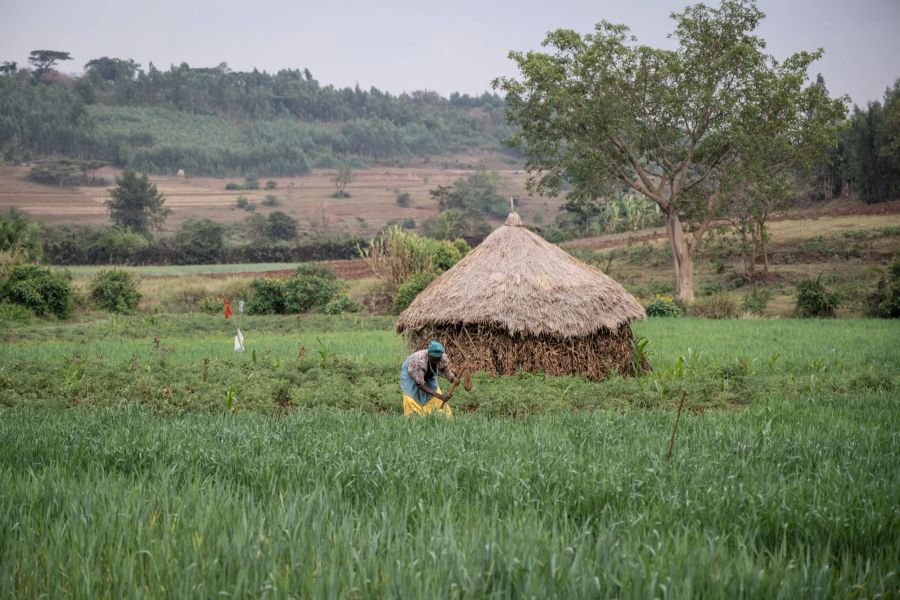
[396,213,645,379]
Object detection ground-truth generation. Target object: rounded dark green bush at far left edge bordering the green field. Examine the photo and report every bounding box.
[0,265,72,319]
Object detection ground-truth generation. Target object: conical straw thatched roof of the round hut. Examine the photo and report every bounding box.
[397,213,645,338]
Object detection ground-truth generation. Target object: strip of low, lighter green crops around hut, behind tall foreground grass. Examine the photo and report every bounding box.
[0,315,900,415]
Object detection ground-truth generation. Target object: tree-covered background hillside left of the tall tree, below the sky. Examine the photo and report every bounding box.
[0,56,508,176]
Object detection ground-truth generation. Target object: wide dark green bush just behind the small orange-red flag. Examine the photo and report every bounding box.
[247,265,341,314]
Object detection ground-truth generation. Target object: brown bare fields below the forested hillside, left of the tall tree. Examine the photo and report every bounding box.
[0,165,562,236]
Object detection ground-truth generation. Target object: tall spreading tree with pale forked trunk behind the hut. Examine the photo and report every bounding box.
[494,0,843,301]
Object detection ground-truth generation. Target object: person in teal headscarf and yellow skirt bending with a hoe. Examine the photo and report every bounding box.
[400,340,459,416]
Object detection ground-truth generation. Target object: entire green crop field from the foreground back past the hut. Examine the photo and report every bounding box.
[0,315,900,598]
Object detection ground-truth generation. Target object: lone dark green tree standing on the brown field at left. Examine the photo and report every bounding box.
[106,169,172,236]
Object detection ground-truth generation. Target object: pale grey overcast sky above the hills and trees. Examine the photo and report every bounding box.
[0,0,900,105]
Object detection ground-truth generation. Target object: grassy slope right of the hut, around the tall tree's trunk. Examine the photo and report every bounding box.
[570,214,900,317]
